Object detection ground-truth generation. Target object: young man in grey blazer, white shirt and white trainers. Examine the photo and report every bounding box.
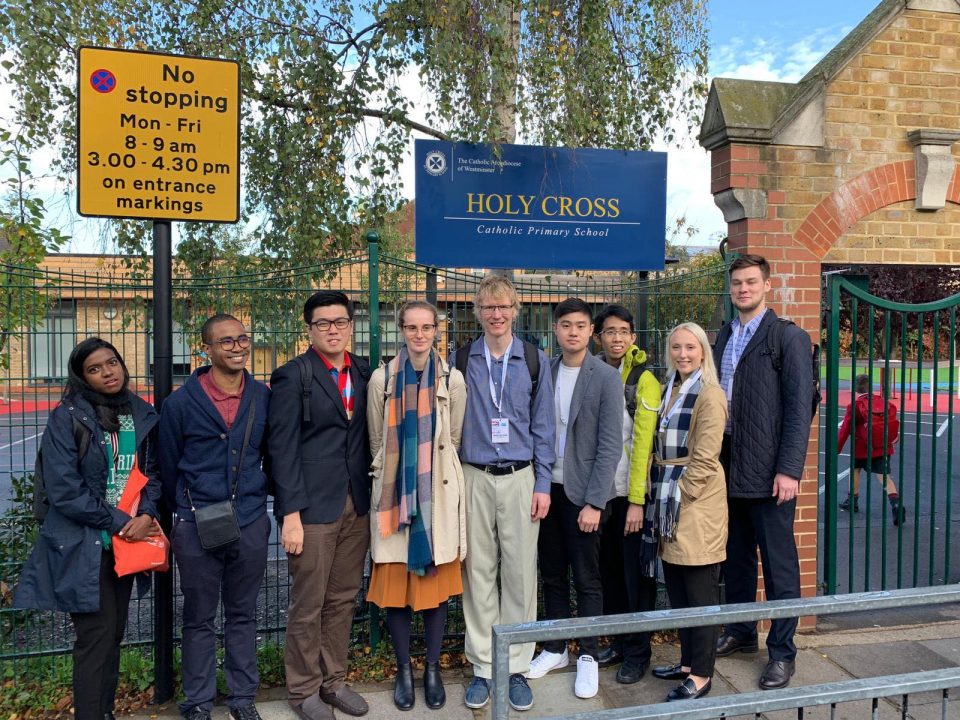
[527,298,623,698]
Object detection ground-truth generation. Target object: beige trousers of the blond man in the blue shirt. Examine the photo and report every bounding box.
[463,463,540,679]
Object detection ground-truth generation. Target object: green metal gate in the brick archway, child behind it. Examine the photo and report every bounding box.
[820,275,960,594]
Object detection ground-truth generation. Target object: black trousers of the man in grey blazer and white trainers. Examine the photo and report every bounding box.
[537,483,603,660]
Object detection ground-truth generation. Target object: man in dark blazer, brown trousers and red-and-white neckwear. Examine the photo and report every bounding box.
[269,290,370,720]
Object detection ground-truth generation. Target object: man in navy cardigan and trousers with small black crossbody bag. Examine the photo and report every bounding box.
[157,314,270,720]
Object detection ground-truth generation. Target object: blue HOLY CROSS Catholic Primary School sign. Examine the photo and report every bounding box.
[415,140,667,270]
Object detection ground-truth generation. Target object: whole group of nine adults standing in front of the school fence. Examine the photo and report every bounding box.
[15,255,812,720]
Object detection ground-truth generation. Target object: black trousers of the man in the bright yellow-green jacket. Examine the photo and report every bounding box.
[600,497,657,666]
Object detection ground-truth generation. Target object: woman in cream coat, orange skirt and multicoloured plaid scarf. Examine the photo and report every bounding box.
[367,301,467,710]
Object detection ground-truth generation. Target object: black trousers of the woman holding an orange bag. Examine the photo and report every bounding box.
[70,550,133,720]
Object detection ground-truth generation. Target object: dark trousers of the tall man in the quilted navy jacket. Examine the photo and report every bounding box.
[720,435,800,660]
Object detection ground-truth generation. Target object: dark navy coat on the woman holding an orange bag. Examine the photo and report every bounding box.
[13,395,160,613]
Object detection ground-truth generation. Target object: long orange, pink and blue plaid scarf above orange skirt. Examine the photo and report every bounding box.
[377,346,437,575]
